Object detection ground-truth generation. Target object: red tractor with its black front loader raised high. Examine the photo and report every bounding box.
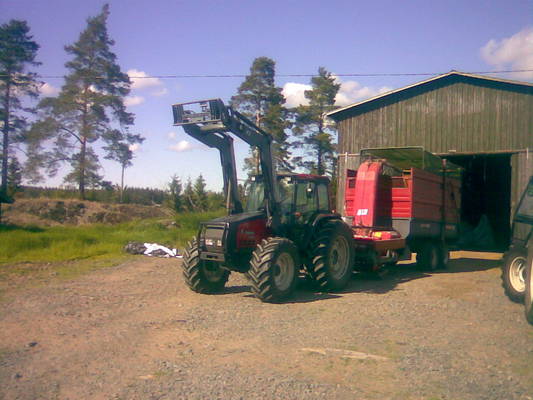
[172,99,354,302]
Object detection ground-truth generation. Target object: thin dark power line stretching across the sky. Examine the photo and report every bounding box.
[0,69,533,79]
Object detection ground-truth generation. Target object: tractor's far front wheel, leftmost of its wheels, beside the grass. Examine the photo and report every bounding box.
[181,238,230,293]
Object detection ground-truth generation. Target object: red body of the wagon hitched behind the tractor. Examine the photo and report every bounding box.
[344,148,460,270]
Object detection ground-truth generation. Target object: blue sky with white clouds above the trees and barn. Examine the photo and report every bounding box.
[0,0,533,190]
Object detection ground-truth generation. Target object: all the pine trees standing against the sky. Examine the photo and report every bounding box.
[0,4,340,216]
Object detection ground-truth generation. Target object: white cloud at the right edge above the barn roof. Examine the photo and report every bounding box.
[480,27,533,79]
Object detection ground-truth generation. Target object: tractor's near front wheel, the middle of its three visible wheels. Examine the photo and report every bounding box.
[248,237,300,303]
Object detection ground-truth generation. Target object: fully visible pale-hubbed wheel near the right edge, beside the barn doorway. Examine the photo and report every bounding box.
[502,247,527,303]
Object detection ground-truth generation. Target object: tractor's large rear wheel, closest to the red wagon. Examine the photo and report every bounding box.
[307,221,355,291]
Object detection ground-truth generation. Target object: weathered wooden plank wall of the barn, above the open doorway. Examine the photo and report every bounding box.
[335,75,533,210]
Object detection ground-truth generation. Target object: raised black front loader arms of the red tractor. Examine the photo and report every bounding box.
[172,99,281,232]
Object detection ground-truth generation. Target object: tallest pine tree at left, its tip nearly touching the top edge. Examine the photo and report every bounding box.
[31,4,134,198]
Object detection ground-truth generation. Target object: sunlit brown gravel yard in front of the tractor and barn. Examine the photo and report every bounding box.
[0,253,533,399]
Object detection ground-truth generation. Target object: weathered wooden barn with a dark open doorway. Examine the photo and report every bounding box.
[328,71,533,247]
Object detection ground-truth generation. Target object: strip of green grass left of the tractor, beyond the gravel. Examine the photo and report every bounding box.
[0,211,224,266]
